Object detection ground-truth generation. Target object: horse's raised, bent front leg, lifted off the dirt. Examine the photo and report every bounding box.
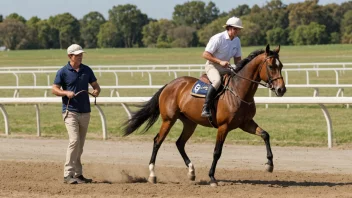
[240,120,274,172]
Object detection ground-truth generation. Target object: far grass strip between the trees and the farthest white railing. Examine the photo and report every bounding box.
[0,45,352,66]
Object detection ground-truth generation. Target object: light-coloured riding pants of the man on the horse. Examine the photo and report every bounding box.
[205,61,230,90]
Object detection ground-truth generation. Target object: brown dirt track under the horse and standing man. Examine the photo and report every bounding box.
[0,138,352,198]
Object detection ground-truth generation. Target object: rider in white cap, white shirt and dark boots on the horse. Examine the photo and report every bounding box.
[202,17,243,117]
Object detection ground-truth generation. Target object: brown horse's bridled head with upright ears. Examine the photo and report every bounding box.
[259,44,286,96]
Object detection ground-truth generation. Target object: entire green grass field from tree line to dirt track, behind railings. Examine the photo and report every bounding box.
[0,45,352,146]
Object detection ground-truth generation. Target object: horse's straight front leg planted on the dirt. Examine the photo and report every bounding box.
[209,125,228,186]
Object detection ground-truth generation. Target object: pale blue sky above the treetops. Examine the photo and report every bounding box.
[0,0,348,20]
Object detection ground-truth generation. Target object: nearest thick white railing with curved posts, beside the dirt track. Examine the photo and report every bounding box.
[0,97,352,148]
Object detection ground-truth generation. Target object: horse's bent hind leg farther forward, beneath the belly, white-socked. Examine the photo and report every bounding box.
[176,116,197,181]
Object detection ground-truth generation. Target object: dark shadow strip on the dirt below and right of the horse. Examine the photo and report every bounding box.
[197,180,352,188]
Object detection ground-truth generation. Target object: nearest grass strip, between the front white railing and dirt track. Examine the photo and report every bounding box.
[0,105,352,146]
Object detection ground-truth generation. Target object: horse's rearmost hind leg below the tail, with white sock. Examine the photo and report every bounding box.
[148,120,176,183]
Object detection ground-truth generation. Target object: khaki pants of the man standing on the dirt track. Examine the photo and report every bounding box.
[62,112,90,177]
